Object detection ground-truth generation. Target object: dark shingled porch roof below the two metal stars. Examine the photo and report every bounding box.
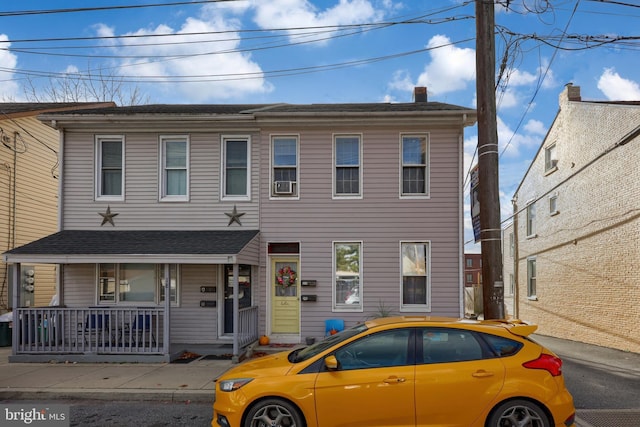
[5,230,258,256]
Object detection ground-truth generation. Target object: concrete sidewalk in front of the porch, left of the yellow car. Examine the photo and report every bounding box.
[0,347,233,402]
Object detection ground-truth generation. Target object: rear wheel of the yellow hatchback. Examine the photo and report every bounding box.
[486,399,551,427]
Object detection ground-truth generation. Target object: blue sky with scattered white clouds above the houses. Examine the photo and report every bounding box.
[0,0,640,252]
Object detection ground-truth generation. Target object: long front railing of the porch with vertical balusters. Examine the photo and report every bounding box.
[13,307,167,354]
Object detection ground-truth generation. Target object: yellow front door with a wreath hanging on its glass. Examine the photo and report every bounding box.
[270,257,300,335]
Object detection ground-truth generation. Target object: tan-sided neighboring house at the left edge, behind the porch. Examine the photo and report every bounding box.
[0,102,114,313]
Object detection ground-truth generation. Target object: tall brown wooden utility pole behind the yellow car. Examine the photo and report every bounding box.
[476,0,505,319]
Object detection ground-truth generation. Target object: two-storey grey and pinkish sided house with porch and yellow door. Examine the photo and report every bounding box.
[4,88,476,361]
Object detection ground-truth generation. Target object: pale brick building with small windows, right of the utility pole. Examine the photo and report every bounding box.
[513,85,640,352]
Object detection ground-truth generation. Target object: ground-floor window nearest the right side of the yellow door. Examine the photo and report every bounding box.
[333,242,362,312]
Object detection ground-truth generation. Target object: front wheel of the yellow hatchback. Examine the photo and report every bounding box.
[244,398,305,427]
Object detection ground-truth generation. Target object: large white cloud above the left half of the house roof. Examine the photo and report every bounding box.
[106,8,272,102]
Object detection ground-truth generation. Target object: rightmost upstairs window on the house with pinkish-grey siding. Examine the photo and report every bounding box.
[400,134,429,197]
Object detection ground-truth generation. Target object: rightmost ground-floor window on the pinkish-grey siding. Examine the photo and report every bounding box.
[400,242,431,311]
